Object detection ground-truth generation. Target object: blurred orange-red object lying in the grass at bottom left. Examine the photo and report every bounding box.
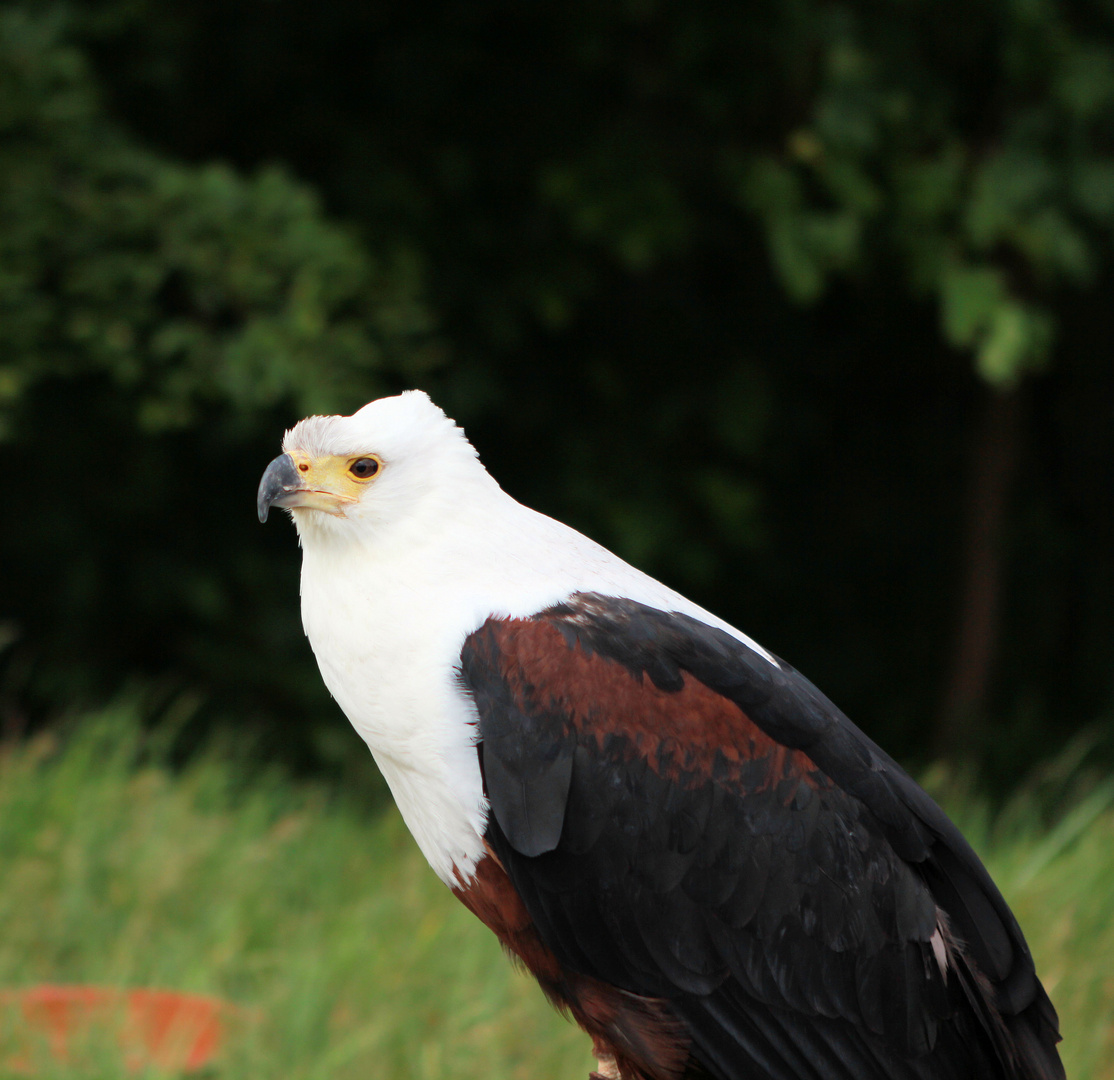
[0,985,236,1072]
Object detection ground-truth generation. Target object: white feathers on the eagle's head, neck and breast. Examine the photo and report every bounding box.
[276,390,773,885]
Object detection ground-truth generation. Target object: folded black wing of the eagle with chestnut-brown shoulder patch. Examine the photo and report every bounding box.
[460,594,1064,1080]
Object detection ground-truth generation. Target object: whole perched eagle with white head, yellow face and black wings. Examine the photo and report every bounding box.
[258,391,1064,1080]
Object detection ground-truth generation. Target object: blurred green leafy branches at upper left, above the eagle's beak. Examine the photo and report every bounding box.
[0,7,429,431]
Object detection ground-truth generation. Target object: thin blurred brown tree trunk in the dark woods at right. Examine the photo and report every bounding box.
[935,388,1023,757]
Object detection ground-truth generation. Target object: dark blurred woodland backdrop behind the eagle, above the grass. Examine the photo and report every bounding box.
[0,0,1114,1076]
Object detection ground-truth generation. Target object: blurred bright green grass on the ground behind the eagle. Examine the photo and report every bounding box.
[0,708,1114,1080]
